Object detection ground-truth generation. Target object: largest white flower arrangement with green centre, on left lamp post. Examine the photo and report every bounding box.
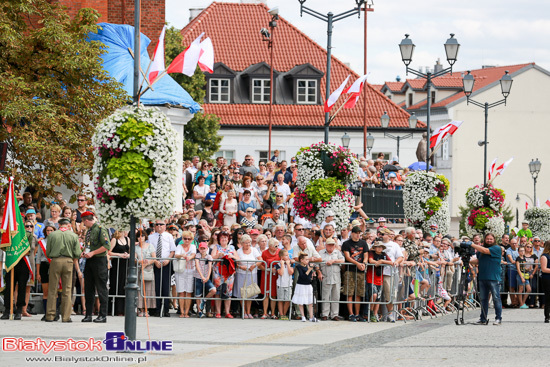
[92,105,177,230]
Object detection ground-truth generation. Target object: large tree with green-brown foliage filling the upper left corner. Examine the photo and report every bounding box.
[0,0,128,195]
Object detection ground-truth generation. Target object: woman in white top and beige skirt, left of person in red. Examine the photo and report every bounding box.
[233,234,262,319]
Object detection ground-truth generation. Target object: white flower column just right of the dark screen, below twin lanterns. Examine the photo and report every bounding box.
[403,171,451,234]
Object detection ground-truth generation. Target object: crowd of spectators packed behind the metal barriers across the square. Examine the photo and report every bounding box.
[0,155,550,322]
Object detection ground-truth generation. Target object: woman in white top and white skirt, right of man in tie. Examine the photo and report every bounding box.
[174,231,197,318]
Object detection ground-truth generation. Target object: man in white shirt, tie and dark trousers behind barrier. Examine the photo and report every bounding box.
[148,219,176,317]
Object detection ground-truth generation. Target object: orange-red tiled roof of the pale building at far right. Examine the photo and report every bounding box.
[408,63,535,111]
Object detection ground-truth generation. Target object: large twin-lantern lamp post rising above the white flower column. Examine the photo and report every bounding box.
[399,33,460,172]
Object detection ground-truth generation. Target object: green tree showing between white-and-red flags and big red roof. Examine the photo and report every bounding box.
[164,27,222,159]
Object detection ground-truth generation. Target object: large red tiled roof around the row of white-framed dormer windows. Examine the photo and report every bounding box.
[181,2,425,128]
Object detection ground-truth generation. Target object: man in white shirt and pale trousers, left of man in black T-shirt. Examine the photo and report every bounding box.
[317,237,344,321]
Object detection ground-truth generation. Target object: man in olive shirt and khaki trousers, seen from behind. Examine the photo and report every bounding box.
[46,218,82,322]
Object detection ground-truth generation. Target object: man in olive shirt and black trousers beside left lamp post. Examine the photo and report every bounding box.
[81,211,111,322]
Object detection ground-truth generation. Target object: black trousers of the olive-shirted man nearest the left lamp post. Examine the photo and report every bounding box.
[84,256,108,317]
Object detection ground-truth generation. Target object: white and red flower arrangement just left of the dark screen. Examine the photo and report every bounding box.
[294,143,359,229]
